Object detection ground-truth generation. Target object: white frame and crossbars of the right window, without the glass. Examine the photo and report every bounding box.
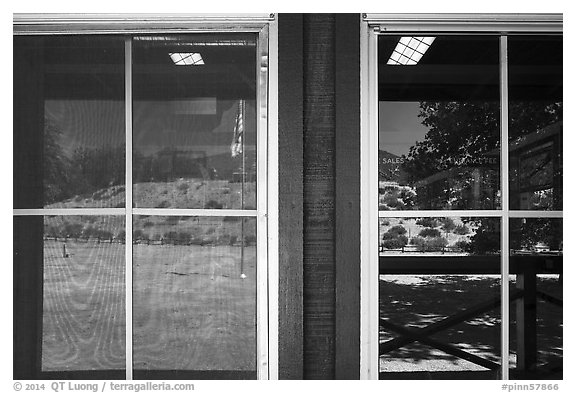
[360,14,563,380]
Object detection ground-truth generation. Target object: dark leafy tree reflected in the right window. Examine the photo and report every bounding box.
[402,101,563,254]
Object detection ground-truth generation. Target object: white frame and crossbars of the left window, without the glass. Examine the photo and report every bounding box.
[13,14,279,380]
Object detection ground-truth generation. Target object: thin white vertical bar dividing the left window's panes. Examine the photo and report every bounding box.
[125,38,133,380]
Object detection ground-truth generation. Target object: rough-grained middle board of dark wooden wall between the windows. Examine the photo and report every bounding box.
[303,14,335,379]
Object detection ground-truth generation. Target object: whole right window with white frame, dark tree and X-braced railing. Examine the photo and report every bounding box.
[361,15,563,379]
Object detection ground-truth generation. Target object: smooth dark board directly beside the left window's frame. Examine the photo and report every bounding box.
[278,14,304,379]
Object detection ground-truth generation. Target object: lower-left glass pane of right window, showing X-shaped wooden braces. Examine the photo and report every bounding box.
[379,217,501,379]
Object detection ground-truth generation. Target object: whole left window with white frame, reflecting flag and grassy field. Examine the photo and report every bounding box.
[14,16,275,379]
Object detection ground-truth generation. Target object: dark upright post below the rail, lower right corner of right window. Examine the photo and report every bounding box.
[516,260,537,373]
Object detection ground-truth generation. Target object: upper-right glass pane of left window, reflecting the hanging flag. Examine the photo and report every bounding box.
[133,34,256,209]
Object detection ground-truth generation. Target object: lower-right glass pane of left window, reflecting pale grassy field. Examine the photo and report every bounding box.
[133,216,256,378]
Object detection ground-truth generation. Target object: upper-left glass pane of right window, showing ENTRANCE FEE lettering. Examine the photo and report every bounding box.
[378,36,500,210]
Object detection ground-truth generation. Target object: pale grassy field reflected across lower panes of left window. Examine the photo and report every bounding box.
[42,240,256,371]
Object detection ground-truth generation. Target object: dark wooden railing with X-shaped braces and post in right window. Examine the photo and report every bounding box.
[379,253,562,372]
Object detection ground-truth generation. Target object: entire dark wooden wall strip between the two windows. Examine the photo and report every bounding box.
[278,14,360,379]
